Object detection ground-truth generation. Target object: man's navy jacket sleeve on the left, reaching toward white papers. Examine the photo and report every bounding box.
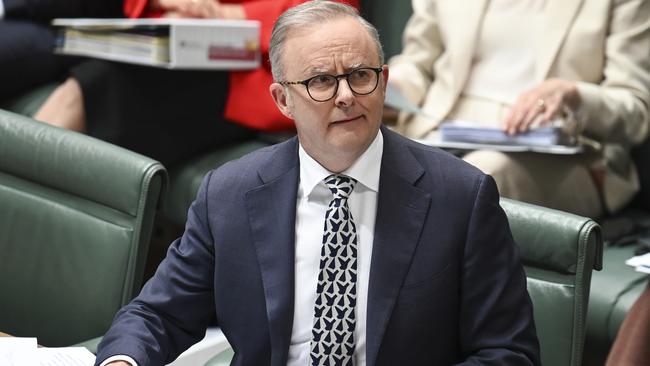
[97,175,215,365]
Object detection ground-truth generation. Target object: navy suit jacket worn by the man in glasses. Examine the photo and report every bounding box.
[97,128,539,366]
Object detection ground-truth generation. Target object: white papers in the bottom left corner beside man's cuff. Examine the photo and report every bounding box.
[0,337,95,366]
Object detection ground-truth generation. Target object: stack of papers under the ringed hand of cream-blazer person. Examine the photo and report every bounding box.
[440,121,565,146]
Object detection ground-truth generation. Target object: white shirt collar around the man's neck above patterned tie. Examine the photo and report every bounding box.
[298,130,384,196]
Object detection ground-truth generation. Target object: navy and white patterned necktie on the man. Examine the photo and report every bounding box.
[310,175,357,366]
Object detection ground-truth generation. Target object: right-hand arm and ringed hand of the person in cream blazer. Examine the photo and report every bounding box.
[504,0,650,145]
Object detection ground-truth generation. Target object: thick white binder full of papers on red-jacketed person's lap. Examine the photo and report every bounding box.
[52,18,261,70]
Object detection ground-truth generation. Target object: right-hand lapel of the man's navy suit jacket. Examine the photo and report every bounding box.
[366,128,431,365]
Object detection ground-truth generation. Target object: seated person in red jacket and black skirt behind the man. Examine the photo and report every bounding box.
[35,0,359,166]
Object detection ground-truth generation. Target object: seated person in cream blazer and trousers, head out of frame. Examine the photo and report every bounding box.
[388,0,650,217]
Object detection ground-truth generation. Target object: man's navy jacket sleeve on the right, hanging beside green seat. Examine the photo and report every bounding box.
[459,175,540,365]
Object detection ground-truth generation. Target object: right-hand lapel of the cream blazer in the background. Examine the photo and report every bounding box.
[535,0,583,82]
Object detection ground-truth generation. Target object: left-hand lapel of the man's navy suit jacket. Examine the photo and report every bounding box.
[246,138,299,365]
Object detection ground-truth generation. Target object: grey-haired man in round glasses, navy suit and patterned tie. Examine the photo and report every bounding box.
[97,1,539,366]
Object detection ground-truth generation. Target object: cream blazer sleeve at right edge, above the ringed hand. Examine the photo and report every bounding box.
[572,0,650,146]
